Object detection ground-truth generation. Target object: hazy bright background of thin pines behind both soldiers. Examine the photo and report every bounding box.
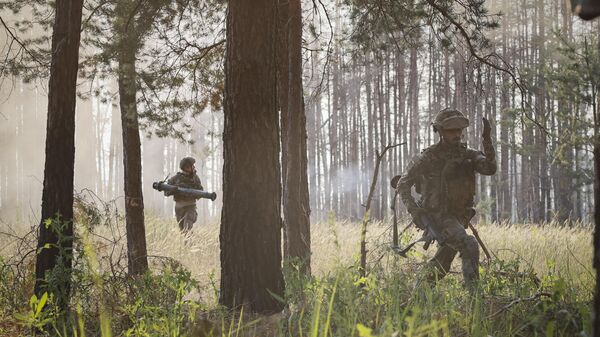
[0,1,598,223]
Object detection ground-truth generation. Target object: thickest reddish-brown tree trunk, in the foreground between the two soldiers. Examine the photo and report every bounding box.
[219,0,284,313]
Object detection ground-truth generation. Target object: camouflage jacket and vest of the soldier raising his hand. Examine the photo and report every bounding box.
[397,140,497,219]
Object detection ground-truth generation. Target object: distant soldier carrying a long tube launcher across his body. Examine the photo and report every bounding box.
[165,157,204,233]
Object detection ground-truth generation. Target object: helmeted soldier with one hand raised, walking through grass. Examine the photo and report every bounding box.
[398,109,496,286]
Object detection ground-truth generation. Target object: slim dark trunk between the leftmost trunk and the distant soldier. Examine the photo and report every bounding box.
[118,31,148,275]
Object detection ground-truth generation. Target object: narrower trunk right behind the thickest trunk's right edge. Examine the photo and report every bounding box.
[283,0,310,273]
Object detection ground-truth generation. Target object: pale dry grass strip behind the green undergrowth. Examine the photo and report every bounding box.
[142,217,595,298]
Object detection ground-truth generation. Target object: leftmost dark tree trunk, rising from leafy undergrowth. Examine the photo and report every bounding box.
[34,0,83,310]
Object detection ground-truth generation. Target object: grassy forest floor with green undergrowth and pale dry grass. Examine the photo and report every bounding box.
[0,210,595,337]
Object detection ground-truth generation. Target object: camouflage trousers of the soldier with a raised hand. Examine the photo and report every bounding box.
[428,215,479,286]
